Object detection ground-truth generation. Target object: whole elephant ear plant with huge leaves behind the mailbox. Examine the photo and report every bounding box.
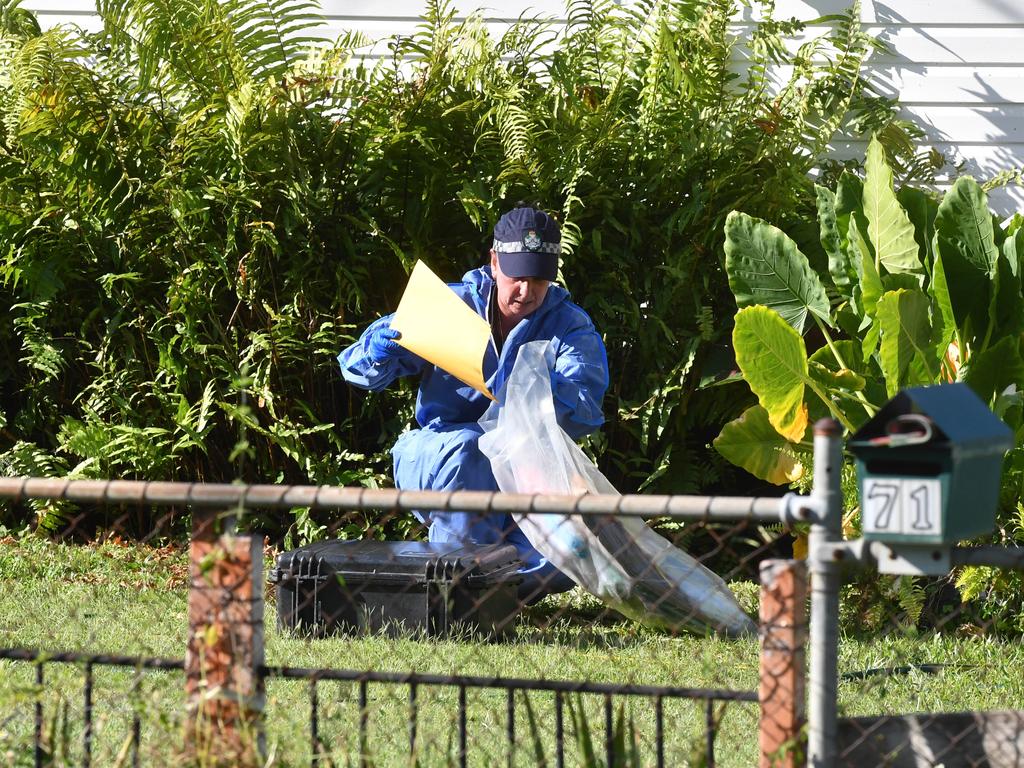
[715,138,1024,493]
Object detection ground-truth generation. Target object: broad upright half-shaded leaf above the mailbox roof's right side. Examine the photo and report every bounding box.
[935,176,998,334]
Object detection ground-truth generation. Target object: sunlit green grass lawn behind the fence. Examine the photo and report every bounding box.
[0,537,1024,767]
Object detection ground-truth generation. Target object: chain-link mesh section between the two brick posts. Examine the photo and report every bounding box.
[258,501,785,766]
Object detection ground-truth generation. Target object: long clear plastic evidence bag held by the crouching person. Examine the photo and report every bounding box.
[479,341,757,635]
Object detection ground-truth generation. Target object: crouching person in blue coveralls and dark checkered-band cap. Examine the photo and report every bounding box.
[338,206,608,602]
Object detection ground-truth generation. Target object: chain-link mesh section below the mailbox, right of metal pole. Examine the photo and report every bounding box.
[836,558,1024,766]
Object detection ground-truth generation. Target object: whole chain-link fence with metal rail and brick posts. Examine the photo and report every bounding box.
[0,421,1024,768]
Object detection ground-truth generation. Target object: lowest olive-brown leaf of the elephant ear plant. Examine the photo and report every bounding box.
[713,406,803,485]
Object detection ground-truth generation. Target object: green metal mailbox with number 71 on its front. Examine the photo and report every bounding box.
[848,384,1014,545]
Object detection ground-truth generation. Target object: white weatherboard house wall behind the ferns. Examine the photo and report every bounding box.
[24,0,1024,214]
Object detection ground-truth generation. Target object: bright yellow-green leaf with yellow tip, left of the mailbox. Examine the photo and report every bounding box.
[732,306,808,441]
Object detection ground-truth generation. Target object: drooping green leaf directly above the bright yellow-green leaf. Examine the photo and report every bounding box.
[725,211,831,333]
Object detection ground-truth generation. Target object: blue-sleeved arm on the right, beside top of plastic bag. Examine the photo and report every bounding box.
[551,325,608,439]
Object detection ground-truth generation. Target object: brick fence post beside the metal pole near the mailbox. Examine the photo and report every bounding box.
[758,560,807,768]
